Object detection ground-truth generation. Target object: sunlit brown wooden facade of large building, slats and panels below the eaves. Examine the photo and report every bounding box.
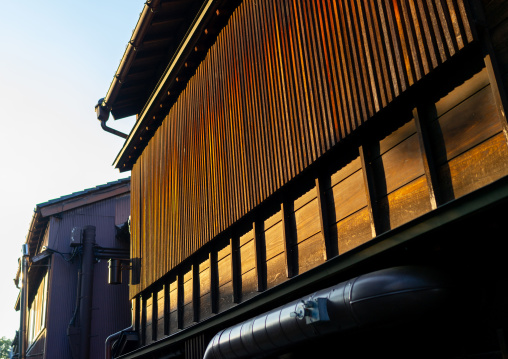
[101,0,508,358]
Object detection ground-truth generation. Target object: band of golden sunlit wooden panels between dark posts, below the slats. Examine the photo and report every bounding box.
[134,64,508,344]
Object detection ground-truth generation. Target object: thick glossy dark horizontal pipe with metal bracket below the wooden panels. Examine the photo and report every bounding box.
[204,267,448,359]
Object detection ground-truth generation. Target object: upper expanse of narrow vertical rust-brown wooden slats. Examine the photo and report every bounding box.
[131,0,473,296]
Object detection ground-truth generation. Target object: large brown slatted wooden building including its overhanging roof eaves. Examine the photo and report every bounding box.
[96,0,508,359]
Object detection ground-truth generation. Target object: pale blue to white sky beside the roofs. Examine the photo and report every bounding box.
[0,0,144,338]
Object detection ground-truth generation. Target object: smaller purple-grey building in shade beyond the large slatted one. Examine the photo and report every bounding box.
[15,178,131,359]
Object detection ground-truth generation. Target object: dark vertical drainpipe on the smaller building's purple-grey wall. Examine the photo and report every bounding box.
[79,226,95,359]
